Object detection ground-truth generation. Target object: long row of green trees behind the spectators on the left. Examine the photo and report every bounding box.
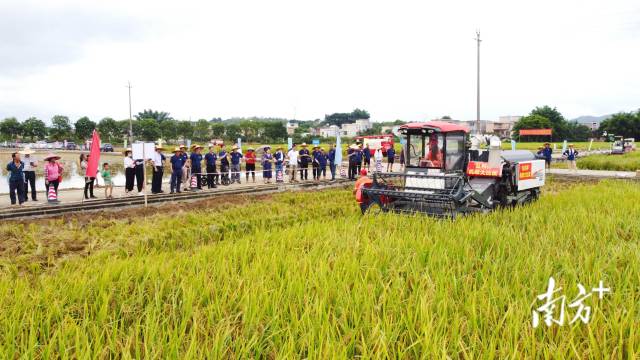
[0,110,287,143]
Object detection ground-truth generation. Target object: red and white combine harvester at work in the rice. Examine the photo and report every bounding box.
[361,121,545,218]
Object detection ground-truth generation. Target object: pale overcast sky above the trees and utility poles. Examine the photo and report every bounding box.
[0,0,640,121]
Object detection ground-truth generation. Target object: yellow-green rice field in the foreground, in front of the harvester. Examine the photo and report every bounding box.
[0,182,640,359]
